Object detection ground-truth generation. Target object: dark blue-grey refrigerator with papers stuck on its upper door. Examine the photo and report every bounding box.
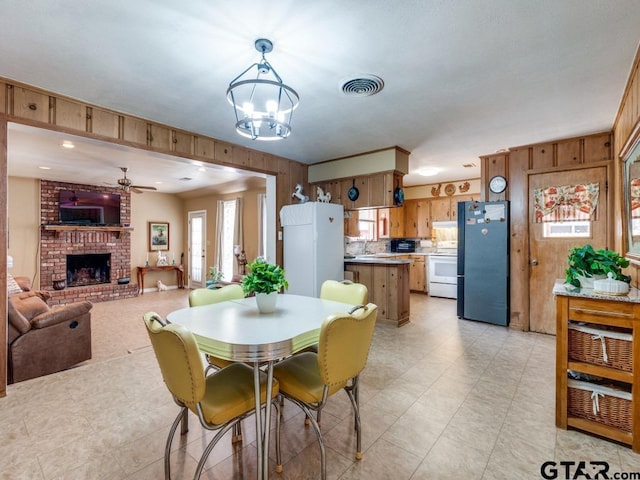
[457,202,509,326]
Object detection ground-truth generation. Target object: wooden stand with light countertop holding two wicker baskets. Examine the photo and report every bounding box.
[553,281,640,453]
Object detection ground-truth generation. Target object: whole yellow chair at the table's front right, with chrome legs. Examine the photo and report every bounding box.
[273,303,378,480]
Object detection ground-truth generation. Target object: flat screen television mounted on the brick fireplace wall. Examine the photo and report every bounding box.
[59,190,120,226]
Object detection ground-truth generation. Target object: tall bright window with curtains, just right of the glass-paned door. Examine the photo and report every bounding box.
[216,198,244,281]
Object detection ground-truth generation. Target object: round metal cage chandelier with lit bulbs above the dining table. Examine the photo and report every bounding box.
[227,38,300,140]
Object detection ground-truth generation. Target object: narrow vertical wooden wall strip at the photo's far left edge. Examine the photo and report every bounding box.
[0,115,9,397]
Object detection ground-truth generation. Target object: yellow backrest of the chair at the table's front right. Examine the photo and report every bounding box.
[318,303,378,386]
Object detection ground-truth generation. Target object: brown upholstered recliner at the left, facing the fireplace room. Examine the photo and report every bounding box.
[7,291,93,383]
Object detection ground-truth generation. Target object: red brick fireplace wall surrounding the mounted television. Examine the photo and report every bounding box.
[40,180,138,305]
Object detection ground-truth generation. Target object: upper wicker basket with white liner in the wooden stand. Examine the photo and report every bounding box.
[569,323,633,372]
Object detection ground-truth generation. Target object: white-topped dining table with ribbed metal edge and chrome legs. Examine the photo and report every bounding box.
[167,294,355,480]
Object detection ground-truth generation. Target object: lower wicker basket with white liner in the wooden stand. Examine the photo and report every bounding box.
[567,379,633,432]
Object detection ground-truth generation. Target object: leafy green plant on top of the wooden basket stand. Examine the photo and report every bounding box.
[566,244,631,287]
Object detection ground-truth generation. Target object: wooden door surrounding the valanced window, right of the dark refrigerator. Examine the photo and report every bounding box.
[529,167,609,335]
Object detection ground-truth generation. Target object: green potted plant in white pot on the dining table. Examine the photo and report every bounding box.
[242,257,289,313]
